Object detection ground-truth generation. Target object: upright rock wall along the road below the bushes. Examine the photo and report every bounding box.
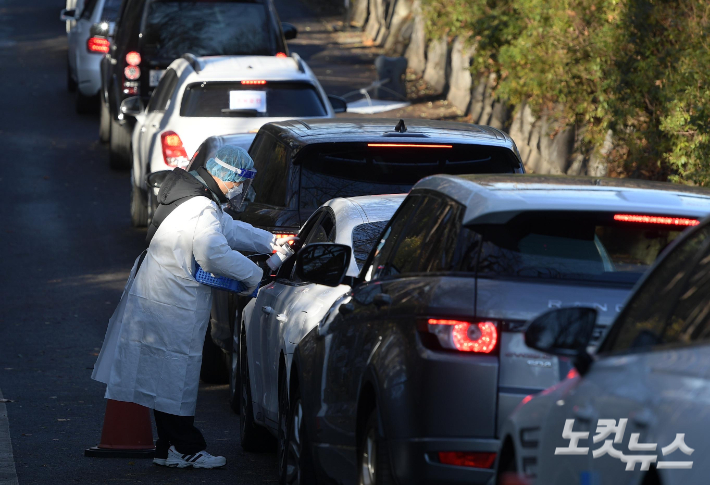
[350,0,613,176]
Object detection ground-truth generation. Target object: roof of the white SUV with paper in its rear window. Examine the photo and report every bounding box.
[183,56,311,81]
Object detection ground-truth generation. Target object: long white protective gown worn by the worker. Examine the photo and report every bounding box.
[92,197,274,416]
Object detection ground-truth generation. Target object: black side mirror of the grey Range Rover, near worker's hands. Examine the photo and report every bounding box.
[296,243,352,287]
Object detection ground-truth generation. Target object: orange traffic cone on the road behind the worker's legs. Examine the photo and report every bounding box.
[84,399,155,458]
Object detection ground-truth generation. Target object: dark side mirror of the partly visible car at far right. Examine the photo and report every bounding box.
[525,307,597,375]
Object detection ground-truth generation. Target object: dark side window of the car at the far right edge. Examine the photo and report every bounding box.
[599,226,710,353]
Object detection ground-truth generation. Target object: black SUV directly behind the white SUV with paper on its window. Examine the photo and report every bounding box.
[100,0,297,168]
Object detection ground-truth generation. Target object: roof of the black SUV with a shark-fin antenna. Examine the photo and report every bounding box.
[261,118,517,149]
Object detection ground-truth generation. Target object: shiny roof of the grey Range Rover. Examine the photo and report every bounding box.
[412,175,710,224]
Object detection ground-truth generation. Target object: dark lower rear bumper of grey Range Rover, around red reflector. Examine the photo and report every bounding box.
[389,438,499,485]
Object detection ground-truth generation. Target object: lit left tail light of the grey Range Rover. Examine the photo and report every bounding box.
[427,318,498,354]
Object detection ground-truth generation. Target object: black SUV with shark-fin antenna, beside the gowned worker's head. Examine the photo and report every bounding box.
[190,118,524,404]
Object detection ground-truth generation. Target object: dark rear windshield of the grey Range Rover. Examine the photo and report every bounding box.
[472,212,696,286]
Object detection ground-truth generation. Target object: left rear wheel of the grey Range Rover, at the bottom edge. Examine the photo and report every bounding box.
[357,408,395,485]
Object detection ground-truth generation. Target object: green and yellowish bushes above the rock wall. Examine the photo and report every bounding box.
[422,0,710,185]
